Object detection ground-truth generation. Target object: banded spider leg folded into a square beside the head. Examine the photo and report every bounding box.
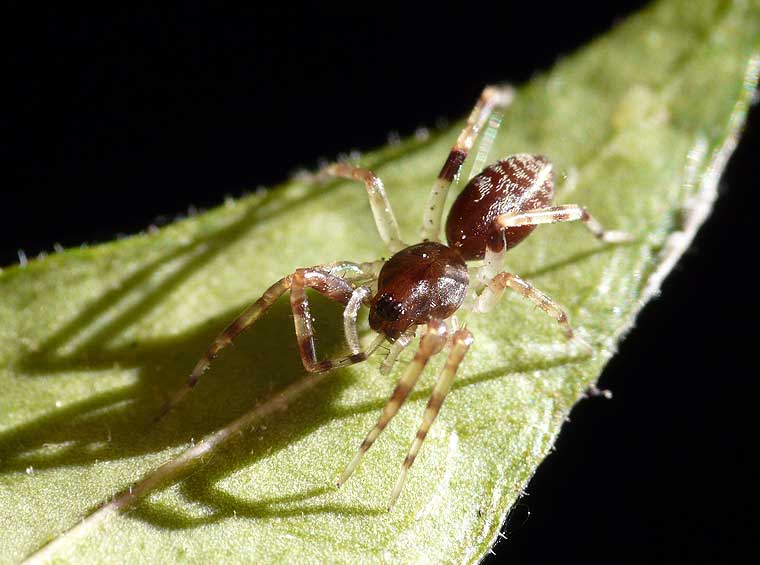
[290,268,380,373]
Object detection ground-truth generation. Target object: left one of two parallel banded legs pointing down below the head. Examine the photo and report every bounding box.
[337,321,447,486]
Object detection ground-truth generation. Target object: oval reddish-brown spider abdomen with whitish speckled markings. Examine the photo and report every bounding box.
[446,153,554,261]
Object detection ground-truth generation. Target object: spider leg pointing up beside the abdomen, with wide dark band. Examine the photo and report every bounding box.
[421,86,514,241]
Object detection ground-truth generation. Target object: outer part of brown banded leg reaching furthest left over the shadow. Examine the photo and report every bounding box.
[155,275,293,421]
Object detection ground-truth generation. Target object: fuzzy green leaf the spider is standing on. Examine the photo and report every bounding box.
[0,0,760,562]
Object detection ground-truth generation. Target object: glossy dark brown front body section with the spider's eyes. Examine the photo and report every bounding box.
[369,241,469,340]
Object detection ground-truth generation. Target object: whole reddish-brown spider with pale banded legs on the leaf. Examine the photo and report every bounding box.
[161,86,628,509]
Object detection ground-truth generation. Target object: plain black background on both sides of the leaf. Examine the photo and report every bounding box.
[0,2,760,562]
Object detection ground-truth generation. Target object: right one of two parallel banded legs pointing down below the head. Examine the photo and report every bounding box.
[388,328,473,510]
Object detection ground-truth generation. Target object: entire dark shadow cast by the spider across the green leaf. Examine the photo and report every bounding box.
[0,114,592,528]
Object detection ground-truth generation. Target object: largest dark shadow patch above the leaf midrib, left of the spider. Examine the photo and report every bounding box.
[0,297,324,470]
